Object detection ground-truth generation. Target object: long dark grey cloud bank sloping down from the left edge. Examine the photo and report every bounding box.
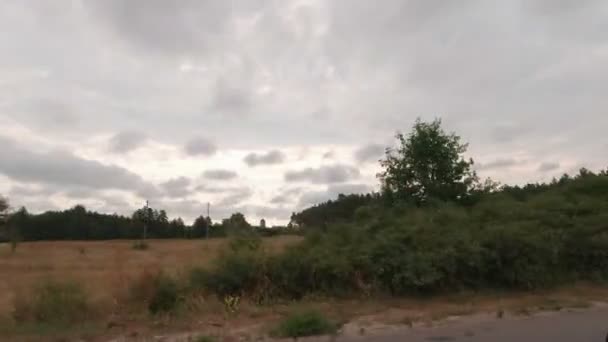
[0,137,157,196]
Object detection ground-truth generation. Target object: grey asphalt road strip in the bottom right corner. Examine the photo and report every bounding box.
[336,307,608,342]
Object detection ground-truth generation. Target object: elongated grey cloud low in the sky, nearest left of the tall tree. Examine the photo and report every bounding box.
[284,164,360,184]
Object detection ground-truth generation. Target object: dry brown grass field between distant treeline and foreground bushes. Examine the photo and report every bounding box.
[0,236,299,316]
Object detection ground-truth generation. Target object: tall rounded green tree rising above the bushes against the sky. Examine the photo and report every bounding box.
[378,119,477,205]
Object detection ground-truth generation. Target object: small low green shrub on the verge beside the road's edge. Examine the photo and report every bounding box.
[273,311,338,338]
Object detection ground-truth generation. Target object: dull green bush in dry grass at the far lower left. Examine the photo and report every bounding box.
[13,281,90,324]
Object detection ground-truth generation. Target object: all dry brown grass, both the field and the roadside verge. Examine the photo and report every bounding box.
[0,236,608,341]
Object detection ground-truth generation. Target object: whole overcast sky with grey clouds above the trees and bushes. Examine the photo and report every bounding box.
[0,0,608,223]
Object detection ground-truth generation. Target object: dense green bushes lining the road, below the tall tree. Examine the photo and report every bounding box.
[198,171,608,299]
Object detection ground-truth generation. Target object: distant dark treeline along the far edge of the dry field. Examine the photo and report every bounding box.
[0,205,286,241]
